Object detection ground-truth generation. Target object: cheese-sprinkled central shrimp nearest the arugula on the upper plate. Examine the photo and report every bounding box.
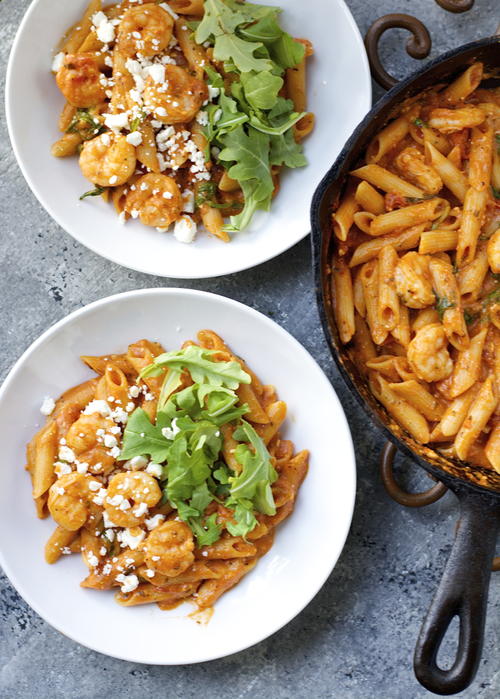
[144,64,208,124]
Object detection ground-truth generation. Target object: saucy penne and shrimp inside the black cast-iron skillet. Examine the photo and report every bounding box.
[332,63,500,473]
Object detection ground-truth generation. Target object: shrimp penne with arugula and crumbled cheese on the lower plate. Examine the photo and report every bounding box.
[27,330,308,609]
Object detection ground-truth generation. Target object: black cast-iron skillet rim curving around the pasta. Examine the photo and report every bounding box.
[311,36,500,498]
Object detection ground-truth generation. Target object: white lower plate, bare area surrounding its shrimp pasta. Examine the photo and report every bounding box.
[0,289,355,665]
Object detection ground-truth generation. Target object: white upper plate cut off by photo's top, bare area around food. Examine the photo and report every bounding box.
[6,0,371,279]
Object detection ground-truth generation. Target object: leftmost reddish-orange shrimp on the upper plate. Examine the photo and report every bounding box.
[56,53,106,107]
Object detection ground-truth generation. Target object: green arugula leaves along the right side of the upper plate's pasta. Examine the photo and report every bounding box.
[194,0,307,232]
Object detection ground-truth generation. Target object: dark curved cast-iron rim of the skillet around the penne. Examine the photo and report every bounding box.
[311,37,500,493]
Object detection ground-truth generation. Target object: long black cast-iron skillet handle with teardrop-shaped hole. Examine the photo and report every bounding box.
[414,490,500,694]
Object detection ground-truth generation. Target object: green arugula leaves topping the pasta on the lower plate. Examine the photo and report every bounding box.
[120,345,277,546]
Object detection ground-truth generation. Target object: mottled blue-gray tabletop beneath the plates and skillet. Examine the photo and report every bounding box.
[0,0,500,699]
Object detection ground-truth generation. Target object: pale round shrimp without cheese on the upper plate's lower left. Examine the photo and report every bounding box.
[80,133,136,187]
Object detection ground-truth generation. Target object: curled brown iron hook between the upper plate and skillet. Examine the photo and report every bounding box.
[365,12,432,90]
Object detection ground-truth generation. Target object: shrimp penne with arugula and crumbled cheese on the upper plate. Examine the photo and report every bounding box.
[52,0,314,243]
